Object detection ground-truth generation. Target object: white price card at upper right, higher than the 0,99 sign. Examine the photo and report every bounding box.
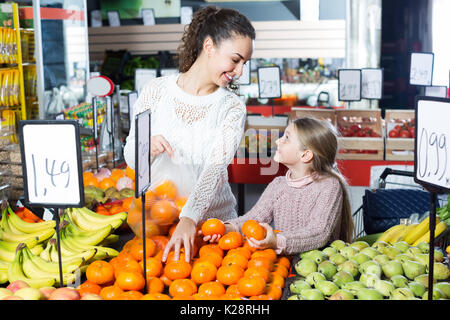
[409,52,434,86]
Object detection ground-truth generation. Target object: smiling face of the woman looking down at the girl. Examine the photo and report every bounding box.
[208,36,253,87]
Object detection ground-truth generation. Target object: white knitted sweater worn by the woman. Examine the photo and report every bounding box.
[124,74,246,223]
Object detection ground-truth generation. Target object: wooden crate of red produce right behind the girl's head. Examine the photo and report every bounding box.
[335,109,384,160]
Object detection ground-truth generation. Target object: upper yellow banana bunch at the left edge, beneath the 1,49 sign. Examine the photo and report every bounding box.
[0,206,56,284]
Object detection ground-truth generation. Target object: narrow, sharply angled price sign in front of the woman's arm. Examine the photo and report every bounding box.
[134,110,151,198]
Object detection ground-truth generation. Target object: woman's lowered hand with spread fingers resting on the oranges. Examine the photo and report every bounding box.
[162,217,196,262]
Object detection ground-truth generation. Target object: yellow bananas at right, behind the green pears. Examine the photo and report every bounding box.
[377,216,447,246]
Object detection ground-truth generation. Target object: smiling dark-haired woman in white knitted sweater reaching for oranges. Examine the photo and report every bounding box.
[124,6,255,261]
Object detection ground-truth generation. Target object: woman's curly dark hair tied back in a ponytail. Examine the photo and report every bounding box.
[178,6,255,90]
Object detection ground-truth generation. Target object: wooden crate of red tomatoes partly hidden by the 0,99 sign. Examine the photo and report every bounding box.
[384,110,415,161]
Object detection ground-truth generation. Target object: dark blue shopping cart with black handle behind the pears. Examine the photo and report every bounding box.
[353,168,440,238]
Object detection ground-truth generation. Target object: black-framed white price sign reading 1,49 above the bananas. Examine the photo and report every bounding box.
[19,120,84,208]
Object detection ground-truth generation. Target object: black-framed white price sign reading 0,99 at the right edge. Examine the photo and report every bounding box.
[414,97,450,192]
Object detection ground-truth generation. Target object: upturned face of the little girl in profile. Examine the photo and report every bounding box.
[274,123,303,165]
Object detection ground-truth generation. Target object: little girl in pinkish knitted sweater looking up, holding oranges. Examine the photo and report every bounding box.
[205,118,354,254]
